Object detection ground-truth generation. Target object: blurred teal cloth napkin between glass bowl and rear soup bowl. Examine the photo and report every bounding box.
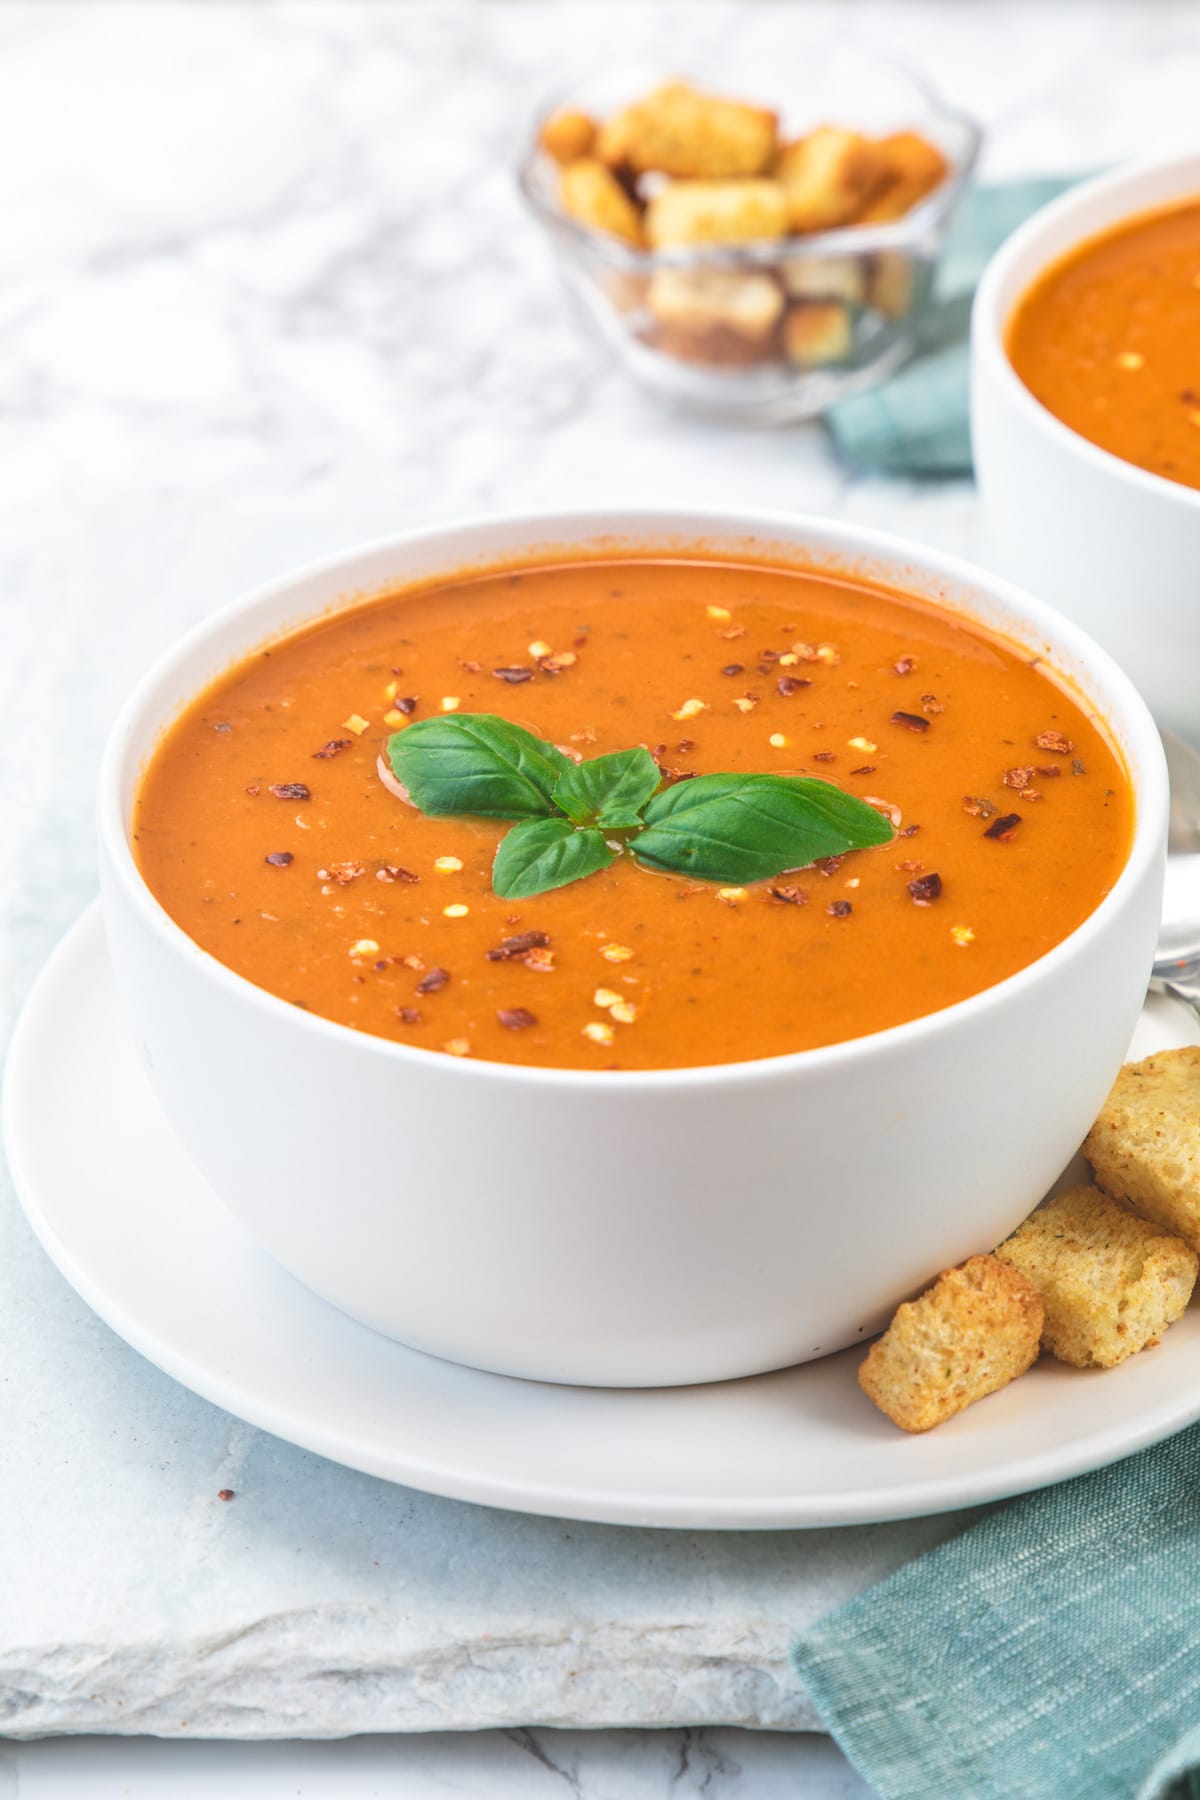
[826,176,1078,475]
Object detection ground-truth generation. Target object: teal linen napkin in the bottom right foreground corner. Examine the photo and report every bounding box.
[793,1418,1200,1800]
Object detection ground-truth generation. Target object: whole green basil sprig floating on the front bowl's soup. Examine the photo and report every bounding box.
[387,713,892,900]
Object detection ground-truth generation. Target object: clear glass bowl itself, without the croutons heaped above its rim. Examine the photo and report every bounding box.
[518,40,979,425]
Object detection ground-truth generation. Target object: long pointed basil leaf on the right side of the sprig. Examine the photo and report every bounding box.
[630,774,892,882]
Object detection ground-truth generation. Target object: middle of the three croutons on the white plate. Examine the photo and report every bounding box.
[995,1188,1200,1368]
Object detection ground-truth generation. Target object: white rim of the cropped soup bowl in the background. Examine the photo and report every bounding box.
[972,151,1200,511]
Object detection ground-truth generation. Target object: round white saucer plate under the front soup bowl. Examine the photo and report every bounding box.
[4,907,1200,1530]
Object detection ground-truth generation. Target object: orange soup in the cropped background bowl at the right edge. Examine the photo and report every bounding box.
[1007,200,1200,488]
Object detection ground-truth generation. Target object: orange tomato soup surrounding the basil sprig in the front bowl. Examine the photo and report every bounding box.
[133,558,1133,1071]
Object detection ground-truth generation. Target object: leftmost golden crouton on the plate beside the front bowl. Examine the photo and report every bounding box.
[858,1256,1043,1431]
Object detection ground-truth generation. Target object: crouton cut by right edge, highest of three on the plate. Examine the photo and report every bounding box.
[1083,1046,1200,1251]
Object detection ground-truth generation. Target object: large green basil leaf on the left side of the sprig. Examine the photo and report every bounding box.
[387,713,574,819]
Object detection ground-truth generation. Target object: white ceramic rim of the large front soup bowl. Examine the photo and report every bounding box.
[97,506,1168,1093]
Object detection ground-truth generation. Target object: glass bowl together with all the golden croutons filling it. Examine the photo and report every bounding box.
[520,45,979,423]
